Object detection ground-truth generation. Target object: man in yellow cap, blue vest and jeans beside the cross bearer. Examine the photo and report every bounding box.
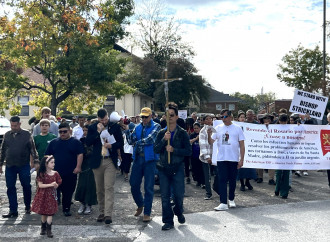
[125,107,160,222]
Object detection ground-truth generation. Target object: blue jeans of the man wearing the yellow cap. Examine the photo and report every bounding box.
[129,156,156,216]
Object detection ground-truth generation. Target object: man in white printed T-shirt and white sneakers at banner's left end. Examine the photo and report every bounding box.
[208,109,245,211]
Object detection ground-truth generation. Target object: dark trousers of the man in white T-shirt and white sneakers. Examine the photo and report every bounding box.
[217,161,238,204]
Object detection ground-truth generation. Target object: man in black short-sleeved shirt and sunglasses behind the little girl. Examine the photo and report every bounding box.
[45,123,84,217]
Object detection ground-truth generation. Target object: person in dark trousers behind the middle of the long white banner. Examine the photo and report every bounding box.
[275,113,290,199]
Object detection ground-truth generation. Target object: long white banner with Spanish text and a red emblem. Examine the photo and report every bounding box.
[213,122,330,170]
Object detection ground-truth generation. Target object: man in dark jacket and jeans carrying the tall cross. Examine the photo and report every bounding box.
[154,102,192,230]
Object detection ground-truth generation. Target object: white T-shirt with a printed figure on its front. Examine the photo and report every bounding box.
[211,124,245,162]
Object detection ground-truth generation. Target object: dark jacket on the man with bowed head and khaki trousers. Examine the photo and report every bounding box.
[86,122,124,169]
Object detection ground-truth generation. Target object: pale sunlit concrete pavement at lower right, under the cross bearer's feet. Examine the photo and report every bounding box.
[135,200,330,242]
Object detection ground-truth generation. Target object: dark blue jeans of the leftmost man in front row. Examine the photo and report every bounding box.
[6,164,32,212]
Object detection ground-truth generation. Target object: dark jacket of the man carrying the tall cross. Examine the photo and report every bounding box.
[154,125,191,174]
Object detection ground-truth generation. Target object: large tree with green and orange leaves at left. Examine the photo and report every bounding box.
[0,0,133,115]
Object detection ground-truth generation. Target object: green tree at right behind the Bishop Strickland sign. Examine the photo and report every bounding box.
[277,45,329,95]
